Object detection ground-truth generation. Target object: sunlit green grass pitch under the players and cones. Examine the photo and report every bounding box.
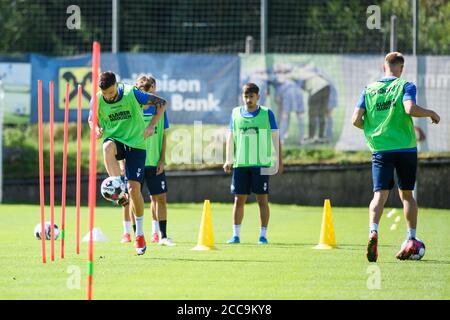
[0,203,450,300]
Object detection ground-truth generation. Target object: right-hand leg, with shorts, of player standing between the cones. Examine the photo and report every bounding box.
[251,168,270,244]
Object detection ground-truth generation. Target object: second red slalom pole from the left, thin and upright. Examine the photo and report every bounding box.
[49,80,55,261]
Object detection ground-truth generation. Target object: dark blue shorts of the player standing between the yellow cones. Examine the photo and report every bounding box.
[231,167,269,194]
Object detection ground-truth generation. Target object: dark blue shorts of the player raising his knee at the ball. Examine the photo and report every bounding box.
[103,138,147,183]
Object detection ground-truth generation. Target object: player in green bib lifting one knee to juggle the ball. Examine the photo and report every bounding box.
[89,71,166,255]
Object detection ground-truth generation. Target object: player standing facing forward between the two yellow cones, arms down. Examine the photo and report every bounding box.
[223,83,283,244]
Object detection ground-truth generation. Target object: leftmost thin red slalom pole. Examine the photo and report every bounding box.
[38,80,47,263]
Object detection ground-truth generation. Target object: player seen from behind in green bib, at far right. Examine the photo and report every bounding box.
[352,52,440,262]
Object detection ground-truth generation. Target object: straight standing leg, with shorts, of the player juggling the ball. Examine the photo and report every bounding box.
[125,147,147,255]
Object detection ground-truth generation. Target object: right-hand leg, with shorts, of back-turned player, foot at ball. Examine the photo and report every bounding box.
[395,152,418,260]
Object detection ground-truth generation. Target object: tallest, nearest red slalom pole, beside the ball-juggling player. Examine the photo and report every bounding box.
[87,41,100,300]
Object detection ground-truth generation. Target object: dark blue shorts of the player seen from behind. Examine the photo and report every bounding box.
[372,152,417,192]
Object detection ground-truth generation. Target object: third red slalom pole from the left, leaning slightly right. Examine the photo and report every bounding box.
[61,83,70,259]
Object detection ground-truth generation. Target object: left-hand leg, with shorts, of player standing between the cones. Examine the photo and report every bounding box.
[227,168,251,244]
